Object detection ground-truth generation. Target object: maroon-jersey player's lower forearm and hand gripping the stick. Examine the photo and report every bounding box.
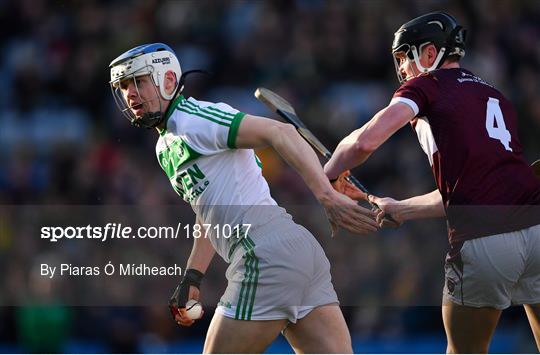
[369,190,446,227]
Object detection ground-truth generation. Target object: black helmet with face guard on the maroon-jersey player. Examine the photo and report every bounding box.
[392,11,466,82]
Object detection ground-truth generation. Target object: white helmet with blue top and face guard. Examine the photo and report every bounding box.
[109,43,183,128]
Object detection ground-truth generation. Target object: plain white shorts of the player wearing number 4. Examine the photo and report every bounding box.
[443,225,540,309]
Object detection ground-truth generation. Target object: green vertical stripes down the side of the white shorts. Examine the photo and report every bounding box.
[234,235,259,320]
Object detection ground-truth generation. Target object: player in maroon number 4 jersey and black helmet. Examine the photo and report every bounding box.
[325,12,540,353]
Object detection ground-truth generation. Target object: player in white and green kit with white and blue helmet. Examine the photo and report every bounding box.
[110,43,377,353]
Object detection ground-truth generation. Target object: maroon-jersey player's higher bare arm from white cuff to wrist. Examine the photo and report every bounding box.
[324,102,414,180]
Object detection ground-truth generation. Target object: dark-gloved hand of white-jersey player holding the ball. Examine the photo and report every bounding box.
[169,269,204,327]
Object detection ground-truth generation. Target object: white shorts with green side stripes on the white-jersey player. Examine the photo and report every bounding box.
[216,218,339,323]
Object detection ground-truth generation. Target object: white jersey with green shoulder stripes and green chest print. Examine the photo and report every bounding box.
[156,96,284,261]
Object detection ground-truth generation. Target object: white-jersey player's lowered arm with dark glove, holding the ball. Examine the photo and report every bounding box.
[169,218,216,327]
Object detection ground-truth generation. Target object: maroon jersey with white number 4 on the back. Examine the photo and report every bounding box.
[392,68,540,244]
